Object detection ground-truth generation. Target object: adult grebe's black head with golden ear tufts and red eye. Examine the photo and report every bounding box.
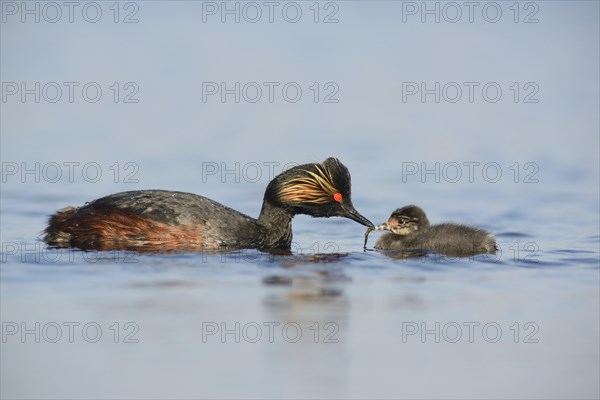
[265,157,374,227]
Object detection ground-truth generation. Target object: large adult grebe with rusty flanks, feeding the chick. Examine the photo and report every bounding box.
[44,158,373,252]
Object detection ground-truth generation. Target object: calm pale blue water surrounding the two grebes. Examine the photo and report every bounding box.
[0,1,600,398]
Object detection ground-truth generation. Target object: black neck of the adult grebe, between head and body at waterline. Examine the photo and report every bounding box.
[258,200,293,248]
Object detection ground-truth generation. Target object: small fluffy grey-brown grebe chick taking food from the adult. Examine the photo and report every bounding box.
[375,205,497,257]
